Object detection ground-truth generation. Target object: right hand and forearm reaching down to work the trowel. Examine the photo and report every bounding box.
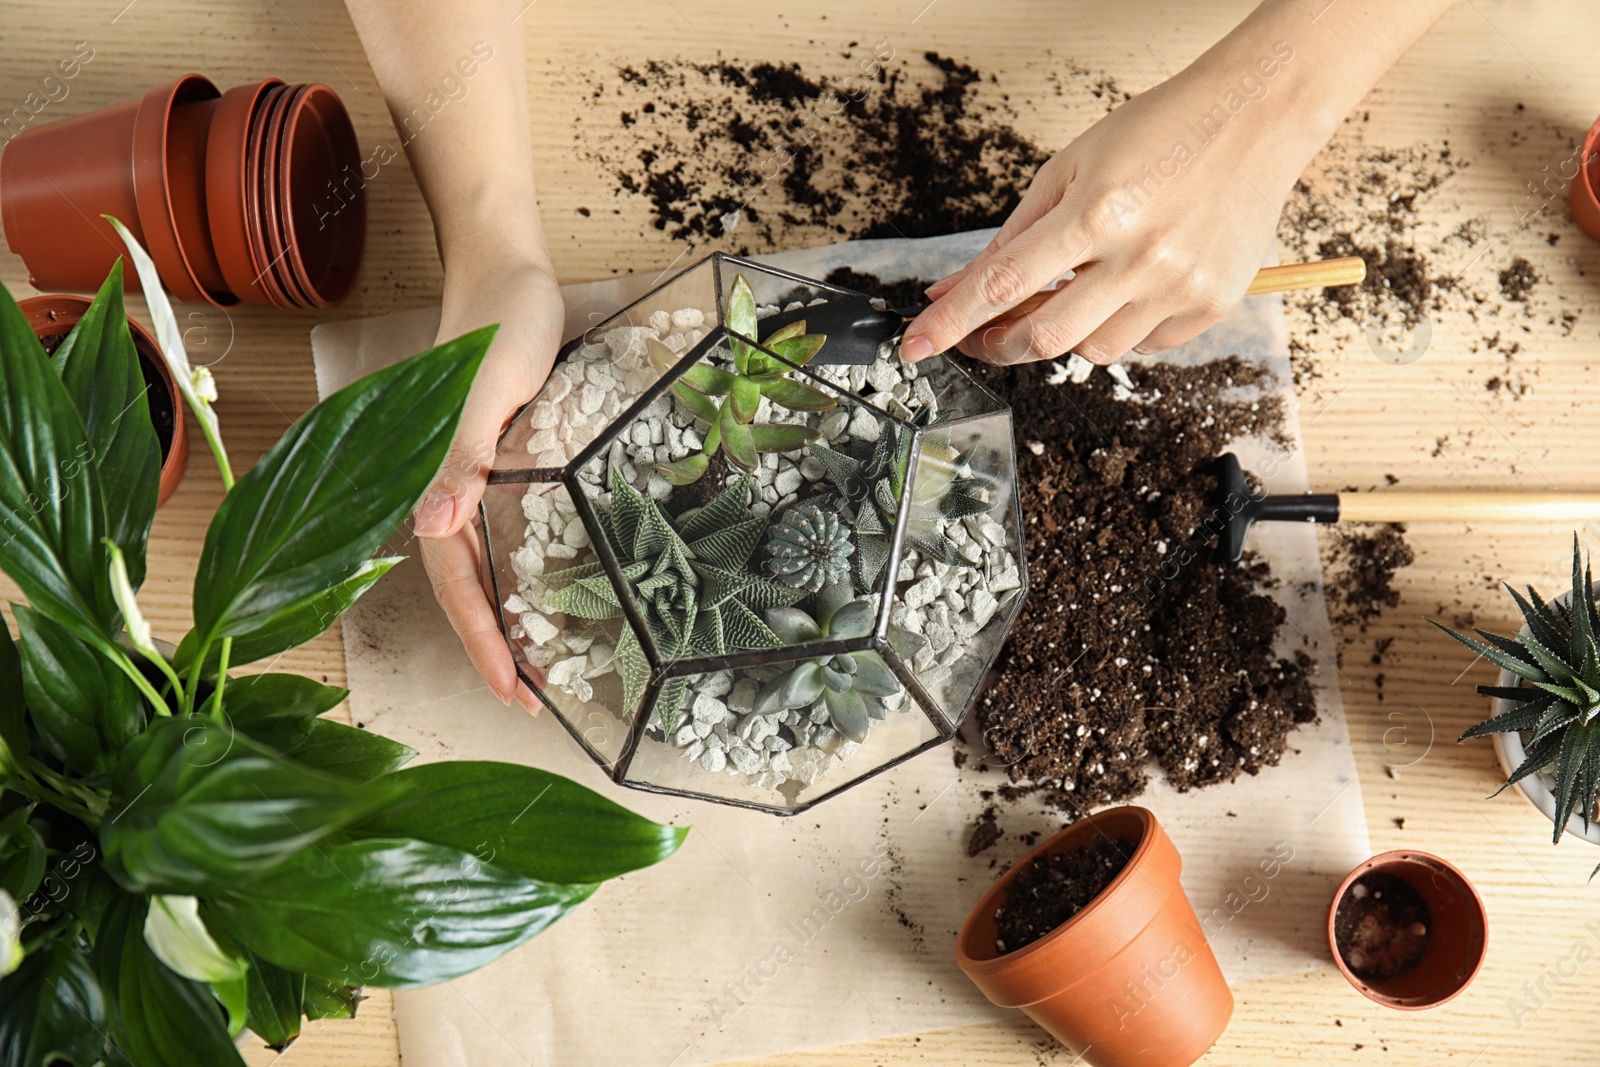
[901,0,1453,365]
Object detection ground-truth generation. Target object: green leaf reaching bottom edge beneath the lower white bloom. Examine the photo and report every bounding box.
[93,893,243,1067]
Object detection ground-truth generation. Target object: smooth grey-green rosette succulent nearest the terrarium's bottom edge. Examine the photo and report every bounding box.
[755,585,901,742]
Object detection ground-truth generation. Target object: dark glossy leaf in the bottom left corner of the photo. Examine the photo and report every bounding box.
[0,941,106,1067]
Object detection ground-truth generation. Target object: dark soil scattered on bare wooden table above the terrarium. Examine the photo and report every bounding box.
[573,46,1050,251]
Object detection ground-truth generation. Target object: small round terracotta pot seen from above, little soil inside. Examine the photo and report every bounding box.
[1328,849,1490,1011]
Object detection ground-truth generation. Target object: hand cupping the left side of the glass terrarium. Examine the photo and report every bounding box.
[413,258,565,712]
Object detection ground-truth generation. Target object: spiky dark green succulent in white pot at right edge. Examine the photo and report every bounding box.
[1434,536,1600,844]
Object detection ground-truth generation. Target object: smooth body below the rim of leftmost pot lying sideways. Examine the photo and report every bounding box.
[0,101,147,293]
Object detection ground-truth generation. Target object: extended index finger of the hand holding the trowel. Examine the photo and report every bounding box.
[901,199,1090,363]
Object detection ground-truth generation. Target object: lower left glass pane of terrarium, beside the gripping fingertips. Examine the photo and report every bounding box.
[483,482,642,768]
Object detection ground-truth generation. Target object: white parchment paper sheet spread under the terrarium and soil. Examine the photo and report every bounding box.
[312,232,1370,1067]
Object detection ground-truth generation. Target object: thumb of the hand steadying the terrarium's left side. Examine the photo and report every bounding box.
[411,341,533,537]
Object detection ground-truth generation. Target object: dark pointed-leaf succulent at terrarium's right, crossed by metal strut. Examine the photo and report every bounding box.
[811,408,994,589]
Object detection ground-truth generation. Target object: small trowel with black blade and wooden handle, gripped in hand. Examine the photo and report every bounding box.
[763,256,1366,366]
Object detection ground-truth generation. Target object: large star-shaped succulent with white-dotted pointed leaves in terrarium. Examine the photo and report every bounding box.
[541,469,803,733]
